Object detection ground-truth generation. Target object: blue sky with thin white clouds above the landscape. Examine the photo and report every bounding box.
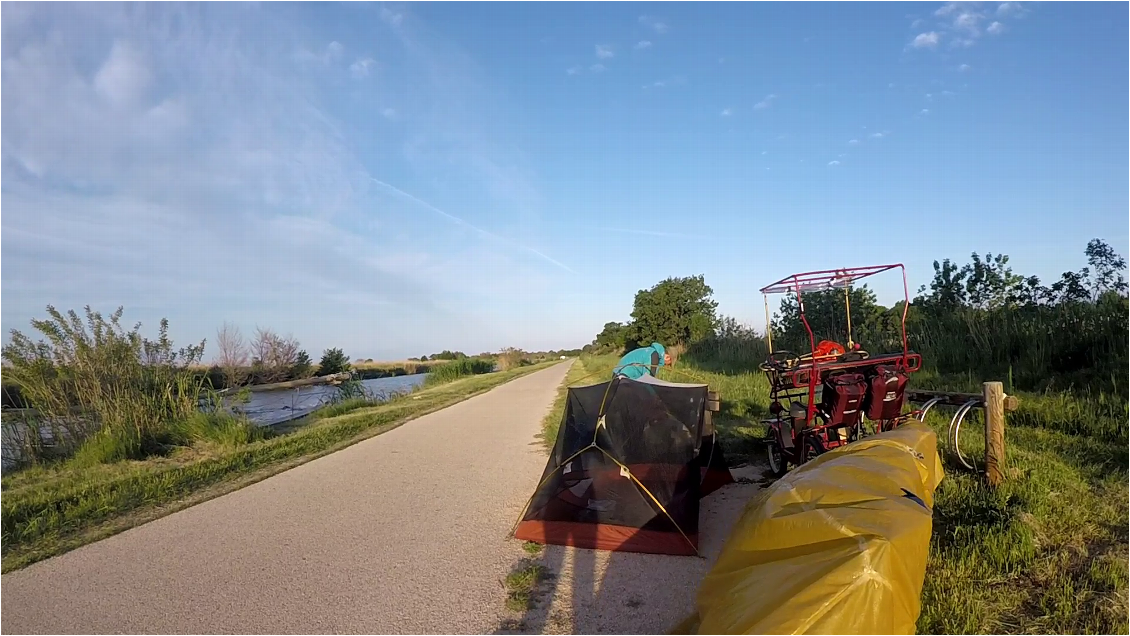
[0,2,1130,358]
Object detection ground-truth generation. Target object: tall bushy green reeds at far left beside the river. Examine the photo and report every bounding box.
[3,306,213,463]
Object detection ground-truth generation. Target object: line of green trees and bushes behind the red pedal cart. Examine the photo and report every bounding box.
[585,238,1130,391]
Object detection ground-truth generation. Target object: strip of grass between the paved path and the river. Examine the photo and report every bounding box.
[0,363,553,572]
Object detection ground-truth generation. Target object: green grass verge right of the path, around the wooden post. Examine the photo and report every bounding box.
[660,350,1130,634]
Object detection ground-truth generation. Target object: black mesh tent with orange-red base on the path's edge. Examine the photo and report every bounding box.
[514,375,733,555]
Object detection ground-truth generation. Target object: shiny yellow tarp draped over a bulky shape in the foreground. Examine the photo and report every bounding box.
[672,421,942,634]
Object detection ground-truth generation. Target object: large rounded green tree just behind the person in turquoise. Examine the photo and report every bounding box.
[626,276,718,346]
